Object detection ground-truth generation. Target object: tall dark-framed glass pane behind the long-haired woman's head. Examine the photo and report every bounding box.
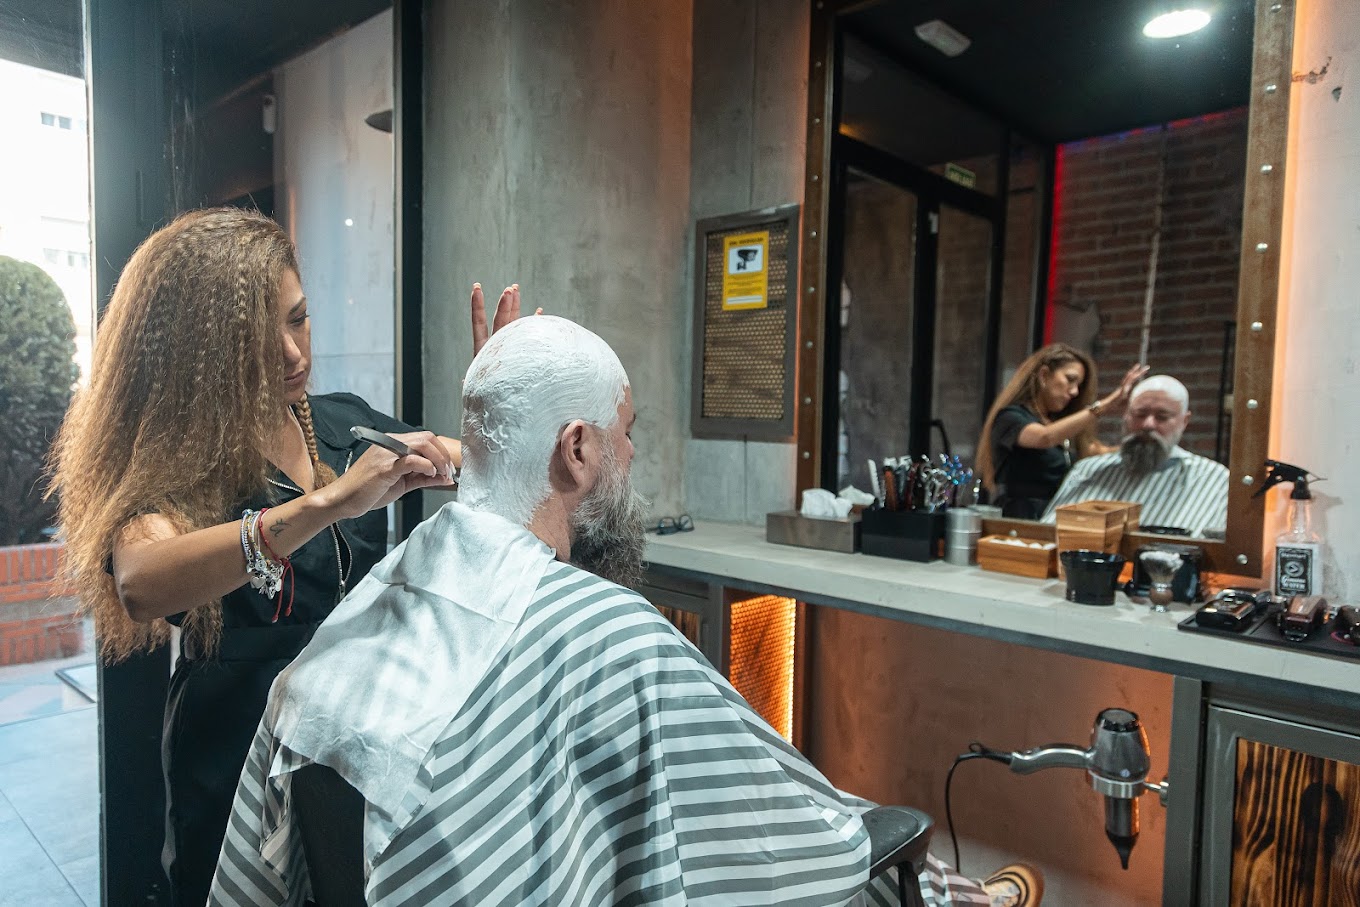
[165,0,396,412]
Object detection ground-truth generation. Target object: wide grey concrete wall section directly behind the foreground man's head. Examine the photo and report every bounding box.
[424,0,691,514]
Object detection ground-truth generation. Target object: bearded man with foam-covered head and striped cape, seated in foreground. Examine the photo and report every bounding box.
[209,315,1011,907]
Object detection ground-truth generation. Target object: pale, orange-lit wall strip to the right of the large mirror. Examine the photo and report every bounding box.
[1263,0,1360,602]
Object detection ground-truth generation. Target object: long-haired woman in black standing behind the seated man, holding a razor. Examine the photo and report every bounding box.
[53,208,518,906]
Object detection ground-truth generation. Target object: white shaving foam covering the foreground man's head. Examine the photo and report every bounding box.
[458,315,628,525]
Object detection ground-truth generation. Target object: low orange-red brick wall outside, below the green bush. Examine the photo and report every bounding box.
[0,544,84,665]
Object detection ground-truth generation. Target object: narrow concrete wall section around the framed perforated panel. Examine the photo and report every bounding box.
[690,0,808,524]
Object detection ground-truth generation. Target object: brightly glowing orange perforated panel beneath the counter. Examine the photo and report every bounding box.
[729,596,796,740]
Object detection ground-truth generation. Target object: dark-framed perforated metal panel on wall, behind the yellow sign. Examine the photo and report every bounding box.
[692,205,798,441]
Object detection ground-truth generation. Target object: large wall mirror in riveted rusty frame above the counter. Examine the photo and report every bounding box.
[800,0,1293,574]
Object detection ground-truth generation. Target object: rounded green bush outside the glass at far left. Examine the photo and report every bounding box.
[0,256,79,545]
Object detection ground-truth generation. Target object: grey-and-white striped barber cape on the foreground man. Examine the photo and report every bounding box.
[211,564,986,907]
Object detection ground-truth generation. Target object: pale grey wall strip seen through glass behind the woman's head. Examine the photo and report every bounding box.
[273,11,396,412]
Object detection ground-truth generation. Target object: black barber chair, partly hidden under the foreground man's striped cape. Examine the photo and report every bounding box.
[292,763,934,907]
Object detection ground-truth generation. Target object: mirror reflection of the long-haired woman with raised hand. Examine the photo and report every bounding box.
[976,343,1148,519]
